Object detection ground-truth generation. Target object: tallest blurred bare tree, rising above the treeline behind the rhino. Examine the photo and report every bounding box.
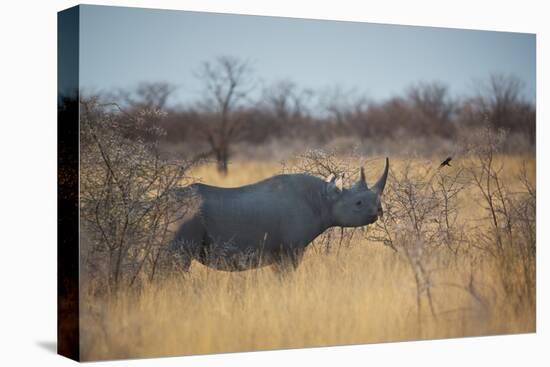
[196,56,255,174]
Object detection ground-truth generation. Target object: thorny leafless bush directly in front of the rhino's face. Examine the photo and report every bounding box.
[367,159,468,325]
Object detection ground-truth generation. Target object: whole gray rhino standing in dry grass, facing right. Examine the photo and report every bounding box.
[170,158,389,271]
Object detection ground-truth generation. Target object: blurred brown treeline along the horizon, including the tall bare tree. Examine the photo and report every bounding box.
[92,57,536,171]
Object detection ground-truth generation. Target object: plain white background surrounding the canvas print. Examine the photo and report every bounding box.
[0,0,550,367]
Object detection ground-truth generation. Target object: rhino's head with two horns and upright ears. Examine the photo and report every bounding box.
[326,158,389,227]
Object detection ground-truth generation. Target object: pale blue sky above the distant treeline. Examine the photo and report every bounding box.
[80,5,536,104]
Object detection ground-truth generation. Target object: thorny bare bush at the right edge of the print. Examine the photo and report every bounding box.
[468,124,536,310]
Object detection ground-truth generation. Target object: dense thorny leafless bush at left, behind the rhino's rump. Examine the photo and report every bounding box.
[80,98,198,292]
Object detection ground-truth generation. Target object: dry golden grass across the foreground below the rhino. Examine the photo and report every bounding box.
[81,157,535,360]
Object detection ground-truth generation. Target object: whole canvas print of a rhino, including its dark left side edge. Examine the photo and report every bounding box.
[58,5,536,361]
